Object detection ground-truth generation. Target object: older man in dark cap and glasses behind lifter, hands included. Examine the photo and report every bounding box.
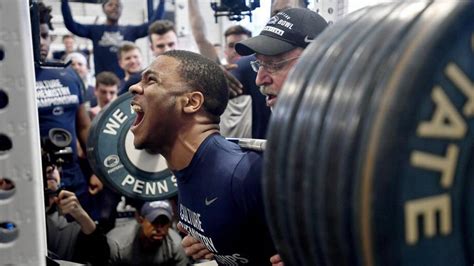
[182,8,328,266]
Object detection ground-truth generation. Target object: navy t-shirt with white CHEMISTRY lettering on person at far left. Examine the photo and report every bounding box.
[35,67,87,194]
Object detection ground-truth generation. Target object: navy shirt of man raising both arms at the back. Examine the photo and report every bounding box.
[61,0,165,78]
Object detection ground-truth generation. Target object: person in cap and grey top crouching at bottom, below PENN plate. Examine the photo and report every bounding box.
[107,201,188,266]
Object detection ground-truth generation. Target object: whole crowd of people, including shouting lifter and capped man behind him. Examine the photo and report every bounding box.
[35,0,327,265]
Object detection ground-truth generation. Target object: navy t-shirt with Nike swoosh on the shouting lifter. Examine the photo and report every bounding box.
[174,134,276,265]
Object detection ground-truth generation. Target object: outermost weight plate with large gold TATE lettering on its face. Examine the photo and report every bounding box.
[354,1,474,265]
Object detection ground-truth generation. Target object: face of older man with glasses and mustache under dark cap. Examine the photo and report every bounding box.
[255,48,303,108]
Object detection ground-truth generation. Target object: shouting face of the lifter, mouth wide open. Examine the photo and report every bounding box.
[129,55,188,153]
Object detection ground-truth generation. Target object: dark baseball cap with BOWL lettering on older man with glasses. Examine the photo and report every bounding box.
[235,8,328,55]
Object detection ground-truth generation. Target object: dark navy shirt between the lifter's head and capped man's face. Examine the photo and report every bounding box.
[231,55,271,139]
